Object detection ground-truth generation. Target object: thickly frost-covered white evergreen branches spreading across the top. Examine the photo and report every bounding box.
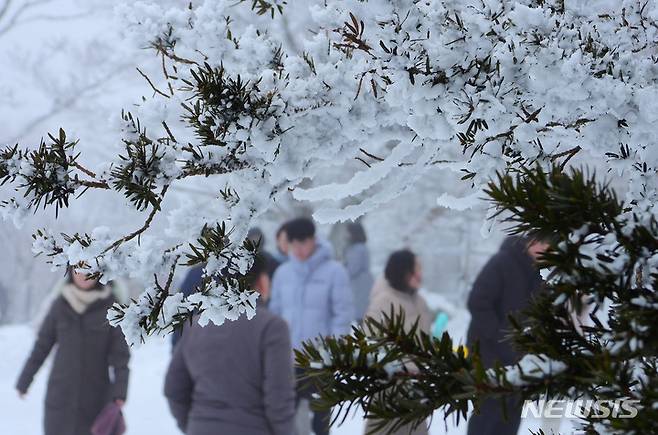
[0,0,658,430]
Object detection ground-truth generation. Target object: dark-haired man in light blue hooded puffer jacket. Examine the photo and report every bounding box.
[270,218,354,435]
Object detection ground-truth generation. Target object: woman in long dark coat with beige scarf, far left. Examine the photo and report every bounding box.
[16,270,130,435]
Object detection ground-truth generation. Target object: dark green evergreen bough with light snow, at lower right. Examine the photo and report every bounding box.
[296,167,658,434]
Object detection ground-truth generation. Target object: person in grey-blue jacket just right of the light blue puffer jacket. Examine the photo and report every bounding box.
[343,222,374,322]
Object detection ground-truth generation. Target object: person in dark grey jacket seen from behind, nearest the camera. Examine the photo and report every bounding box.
[164,258,295,435]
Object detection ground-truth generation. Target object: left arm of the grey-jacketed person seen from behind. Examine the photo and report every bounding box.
[164,335,194,432]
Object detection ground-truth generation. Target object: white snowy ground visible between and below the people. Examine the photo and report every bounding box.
[0,326,570,435]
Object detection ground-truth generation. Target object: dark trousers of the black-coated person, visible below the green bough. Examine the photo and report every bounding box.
[468,397,521,435]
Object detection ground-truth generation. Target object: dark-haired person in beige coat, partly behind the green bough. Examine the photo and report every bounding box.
[365,250,432,435]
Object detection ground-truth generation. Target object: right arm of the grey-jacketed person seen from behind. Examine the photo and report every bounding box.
[262,318,295,435]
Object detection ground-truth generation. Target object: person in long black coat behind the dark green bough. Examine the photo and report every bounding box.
[467,236,549,435]
